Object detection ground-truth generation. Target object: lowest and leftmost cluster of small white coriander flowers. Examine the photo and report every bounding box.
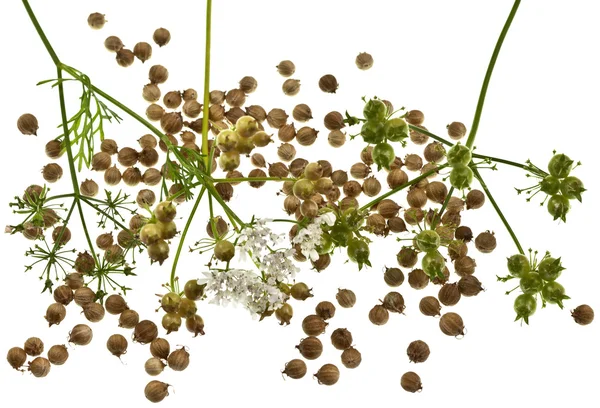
[198,269,286,317]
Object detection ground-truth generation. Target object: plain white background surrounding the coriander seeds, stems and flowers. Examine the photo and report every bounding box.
[0,0,600,408]
